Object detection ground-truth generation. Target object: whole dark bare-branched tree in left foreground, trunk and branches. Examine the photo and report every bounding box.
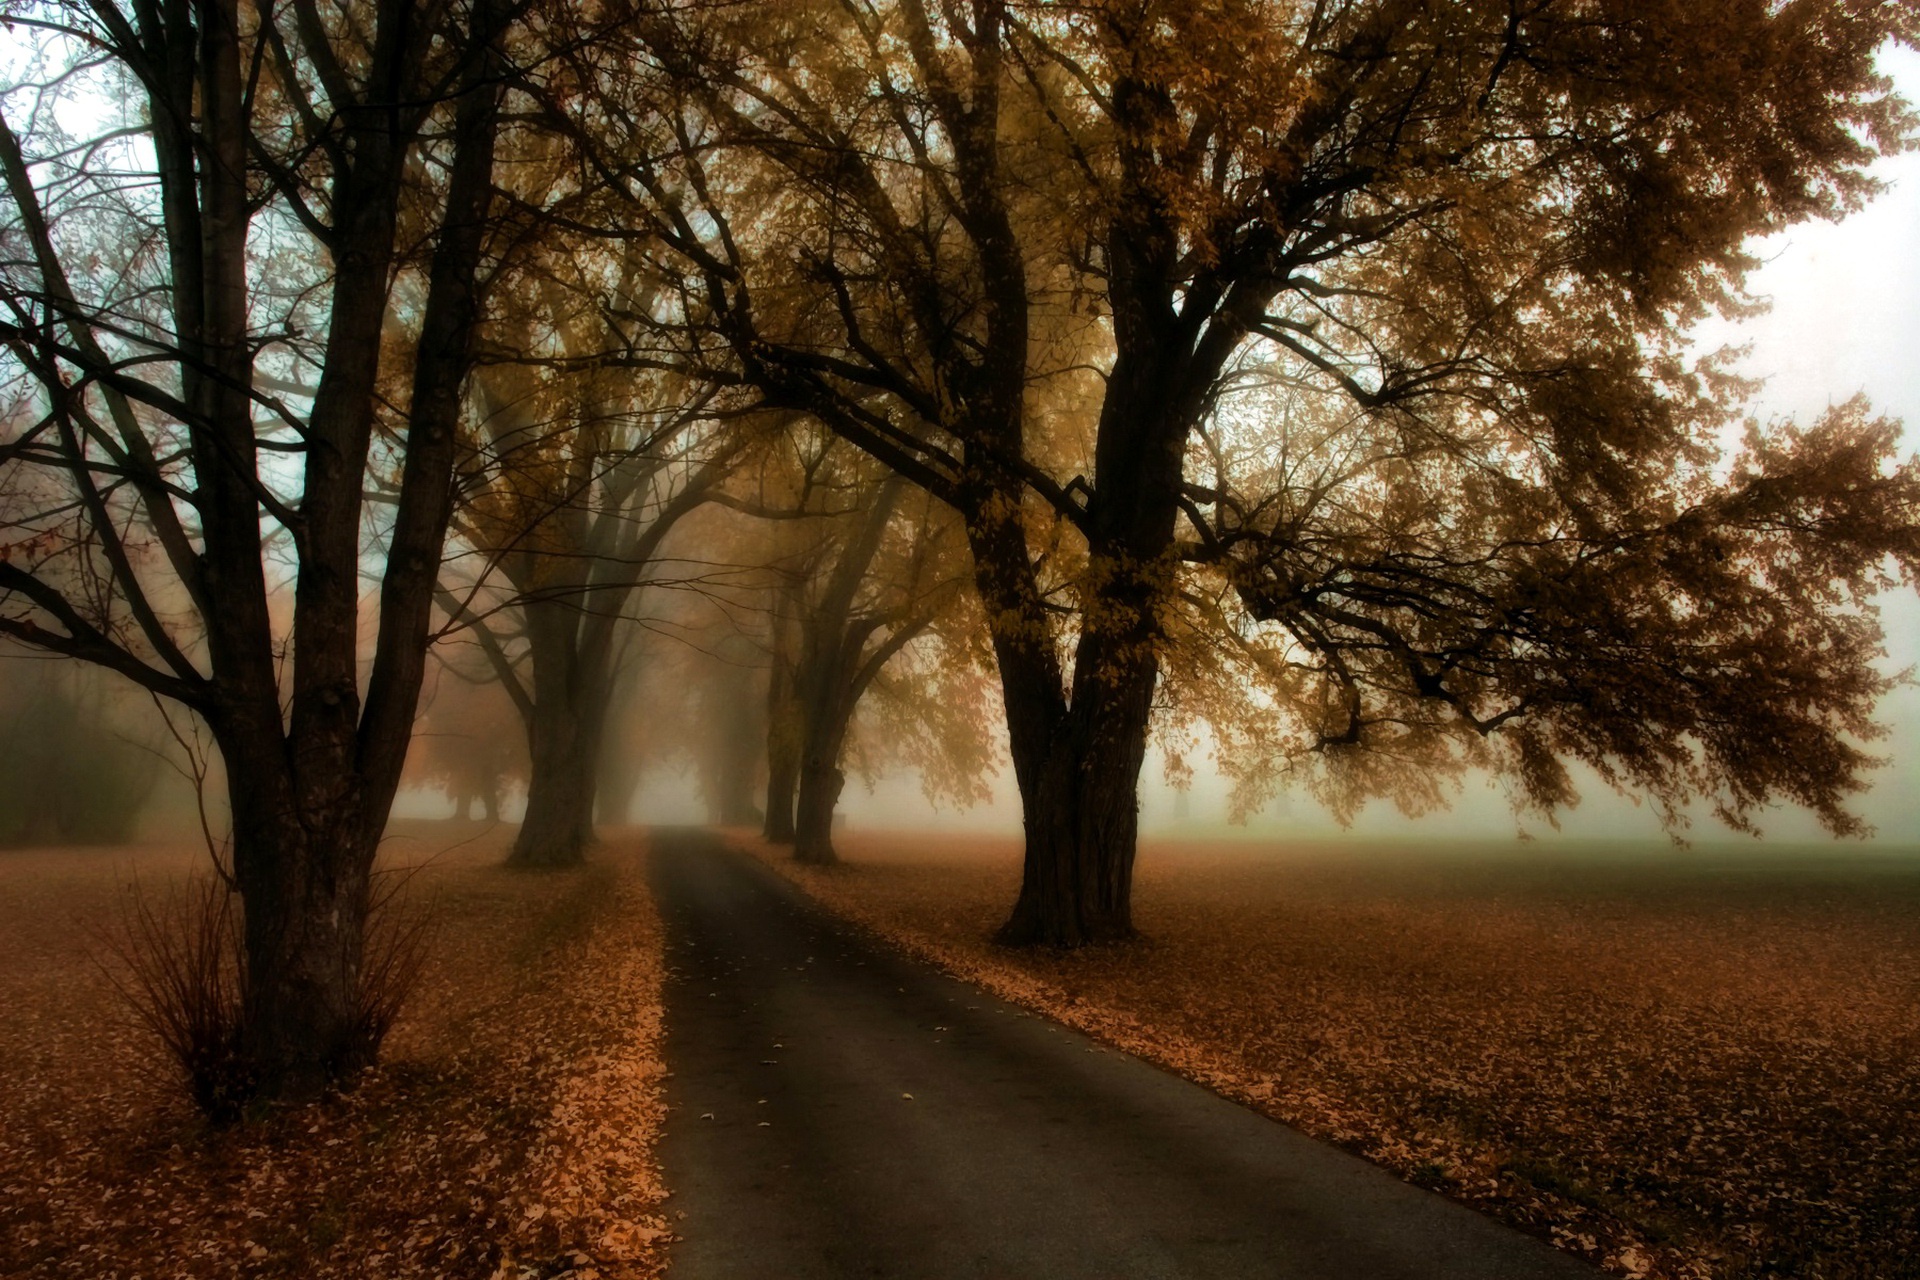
[0,0,511,1096]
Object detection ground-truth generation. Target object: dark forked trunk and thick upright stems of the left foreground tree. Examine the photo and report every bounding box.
[0,0,503,1100]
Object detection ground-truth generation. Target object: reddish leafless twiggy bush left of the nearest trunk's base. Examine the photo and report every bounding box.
[108,877,257,1123]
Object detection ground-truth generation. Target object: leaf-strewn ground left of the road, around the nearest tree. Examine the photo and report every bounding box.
[0,823,666,1280]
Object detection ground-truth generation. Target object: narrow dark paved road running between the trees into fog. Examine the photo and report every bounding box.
[653,831,1599,1280]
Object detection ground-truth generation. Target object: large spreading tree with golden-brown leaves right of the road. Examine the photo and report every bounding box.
[599,0,1920,942]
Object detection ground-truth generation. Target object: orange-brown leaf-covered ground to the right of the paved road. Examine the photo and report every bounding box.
[741,833,1920,1280]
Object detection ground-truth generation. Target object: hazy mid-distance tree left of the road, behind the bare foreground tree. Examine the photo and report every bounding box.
[440,231,743,867]
